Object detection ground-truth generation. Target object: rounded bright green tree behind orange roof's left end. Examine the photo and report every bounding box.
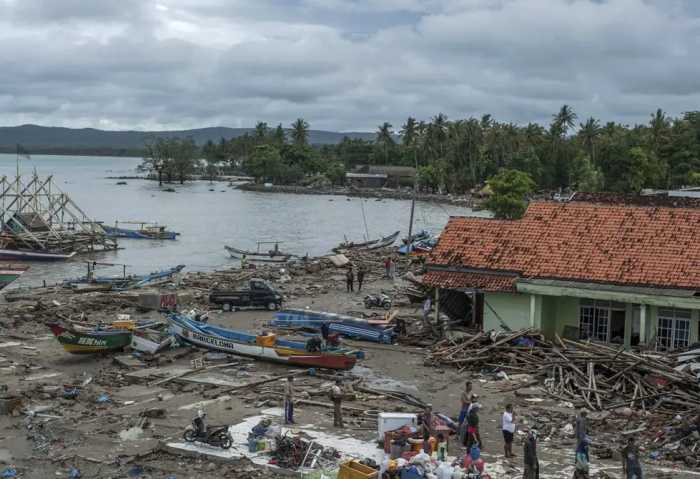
[486,169,535,219]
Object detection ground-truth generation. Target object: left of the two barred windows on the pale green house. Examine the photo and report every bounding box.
[579,299,625,342]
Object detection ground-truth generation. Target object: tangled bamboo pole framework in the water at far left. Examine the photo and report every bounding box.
[0,172,117,254]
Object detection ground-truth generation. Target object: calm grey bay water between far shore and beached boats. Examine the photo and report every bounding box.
[0,154,487,287]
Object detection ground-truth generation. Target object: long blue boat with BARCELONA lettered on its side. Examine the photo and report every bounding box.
[168,314,357,369]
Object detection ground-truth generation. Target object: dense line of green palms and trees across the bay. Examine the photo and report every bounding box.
[141,105,700,194]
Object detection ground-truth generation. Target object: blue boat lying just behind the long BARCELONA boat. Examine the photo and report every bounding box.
[270,309,396,344]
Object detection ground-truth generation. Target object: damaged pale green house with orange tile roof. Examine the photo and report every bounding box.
[423,201,700,349]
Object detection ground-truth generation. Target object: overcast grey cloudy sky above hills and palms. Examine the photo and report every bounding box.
[0,0,700,131]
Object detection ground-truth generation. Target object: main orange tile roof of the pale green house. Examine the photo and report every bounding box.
[427,201,700,289]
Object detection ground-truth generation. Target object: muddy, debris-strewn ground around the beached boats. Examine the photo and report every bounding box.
[0,258,698,478]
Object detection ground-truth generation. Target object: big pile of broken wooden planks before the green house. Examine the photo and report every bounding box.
[427,329,700,416]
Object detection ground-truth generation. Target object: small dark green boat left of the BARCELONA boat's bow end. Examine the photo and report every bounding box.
[49,323,131,354]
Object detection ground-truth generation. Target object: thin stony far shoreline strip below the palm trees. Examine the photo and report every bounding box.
[236,183,484,207]
